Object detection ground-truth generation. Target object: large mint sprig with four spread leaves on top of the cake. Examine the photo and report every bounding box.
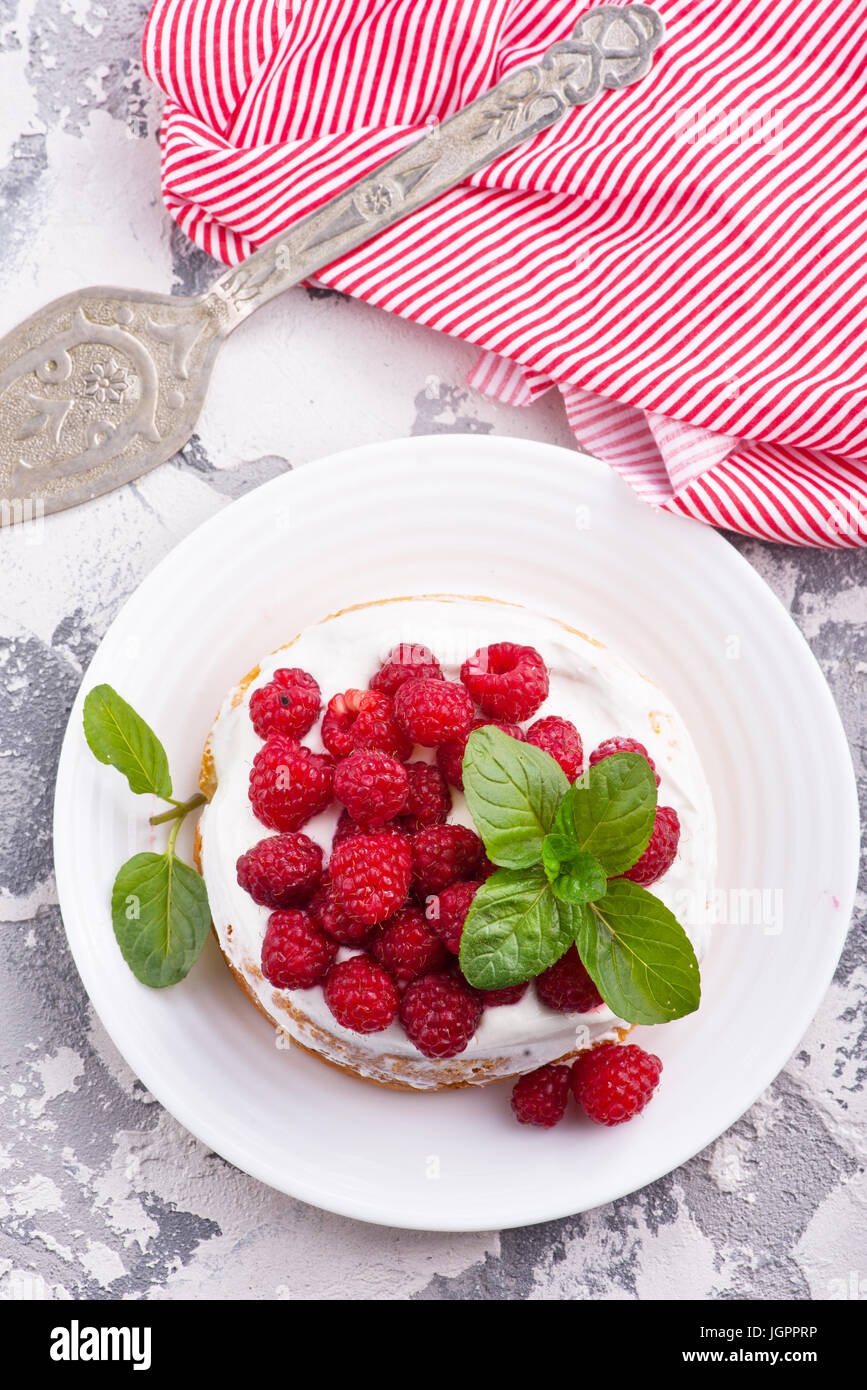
[460,726,700,1023]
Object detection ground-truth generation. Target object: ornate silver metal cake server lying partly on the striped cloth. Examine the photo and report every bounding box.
[0,4,663,513]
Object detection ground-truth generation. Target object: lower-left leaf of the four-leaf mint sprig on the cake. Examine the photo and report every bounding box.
[460,867,574,990]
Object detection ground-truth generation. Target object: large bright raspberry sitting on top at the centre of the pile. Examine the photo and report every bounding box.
[329,830,414,926]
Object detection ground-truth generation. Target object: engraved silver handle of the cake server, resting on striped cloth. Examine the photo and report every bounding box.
[207,4,664,334]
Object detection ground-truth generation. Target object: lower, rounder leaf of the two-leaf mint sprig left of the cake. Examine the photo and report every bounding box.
[111,849,211,990]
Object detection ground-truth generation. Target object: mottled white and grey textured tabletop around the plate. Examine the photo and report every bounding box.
[0,0,867,1300]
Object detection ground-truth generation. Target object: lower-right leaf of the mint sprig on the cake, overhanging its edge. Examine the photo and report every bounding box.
[575,878,702,1023]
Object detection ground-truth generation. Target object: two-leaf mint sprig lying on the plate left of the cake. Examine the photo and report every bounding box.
[83,685,211,990]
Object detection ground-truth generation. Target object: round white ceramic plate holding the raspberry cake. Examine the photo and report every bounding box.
[54,435,859,1230]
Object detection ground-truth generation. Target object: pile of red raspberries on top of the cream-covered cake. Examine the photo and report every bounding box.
[238,642,679,1058]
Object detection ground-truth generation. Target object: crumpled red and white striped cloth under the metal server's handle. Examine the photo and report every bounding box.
[145,0,867,546]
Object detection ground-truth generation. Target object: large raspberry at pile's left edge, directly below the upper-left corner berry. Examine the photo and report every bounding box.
[250,734,333,830]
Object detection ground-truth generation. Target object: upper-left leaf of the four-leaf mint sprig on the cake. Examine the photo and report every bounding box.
[464,727,568,867]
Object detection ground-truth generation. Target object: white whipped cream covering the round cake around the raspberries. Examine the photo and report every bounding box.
[200,596,716,1088]
